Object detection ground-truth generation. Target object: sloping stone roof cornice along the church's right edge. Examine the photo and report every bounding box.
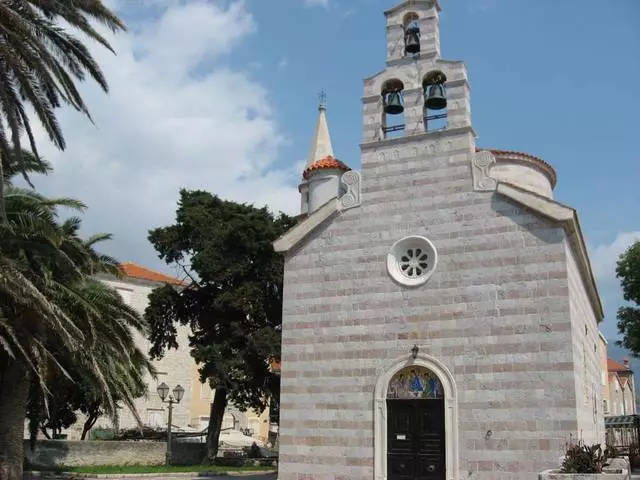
[496,182,604,322]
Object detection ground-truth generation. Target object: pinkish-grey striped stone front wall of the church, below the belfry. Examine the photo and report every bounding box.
[279,135,577,480]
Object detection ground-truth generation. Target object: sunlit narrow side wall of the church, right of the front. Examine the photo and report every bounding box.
[565,242,605,444]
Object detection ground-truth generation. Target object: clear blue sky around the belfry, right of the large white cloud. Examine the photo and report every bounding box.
[245,0,640,342]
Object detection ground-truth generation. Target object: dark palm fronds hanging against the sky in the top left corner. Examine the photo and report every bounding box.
[0,0,126,223]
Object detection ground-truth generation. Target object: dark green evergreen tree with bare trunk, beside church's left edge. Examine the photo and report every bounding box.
[145,190,293,462]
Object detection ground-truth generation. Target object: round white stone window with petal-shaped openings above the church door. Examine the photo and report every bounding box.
[387,236,438,287]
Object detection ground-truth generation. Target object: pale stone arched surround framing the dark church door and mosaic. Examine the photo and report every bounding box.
[373,352,459,480]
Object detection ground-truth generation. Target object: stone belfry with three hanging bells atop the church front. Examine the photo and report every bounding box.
[362,0,475,144]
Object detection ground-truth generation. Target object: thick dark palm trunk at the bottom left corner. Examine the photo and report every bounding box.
[0,352,30,480]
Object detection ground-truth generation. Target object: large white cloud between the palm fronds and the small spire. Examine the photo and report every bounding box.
[26,0,299,268]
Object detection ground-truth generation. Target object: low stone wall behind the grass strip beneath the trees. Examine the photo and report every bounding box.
[24,440,206,467]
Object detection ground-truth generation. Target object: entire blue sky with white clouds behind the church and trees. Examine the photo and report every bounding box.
[26,0,640,338]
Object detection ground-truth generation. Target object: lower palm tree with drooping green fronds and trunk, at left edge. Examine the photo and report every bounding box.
[0,157,150,480]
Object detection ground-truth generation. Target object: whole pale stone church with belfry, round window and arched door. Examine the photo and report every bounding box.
[274,0,604,480]
